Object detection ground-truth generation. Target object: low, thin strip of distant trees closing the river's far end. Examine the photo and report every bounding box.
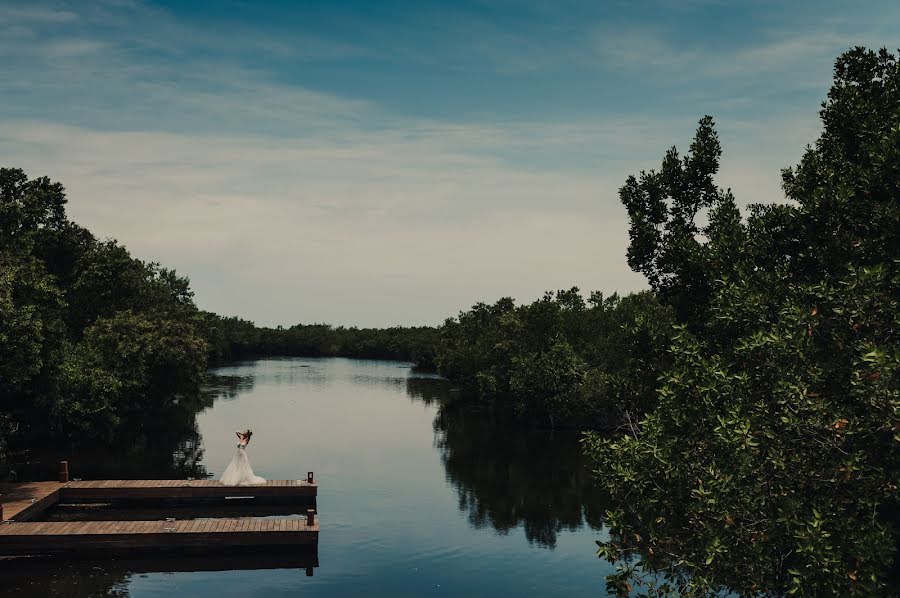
[204,312,439,370]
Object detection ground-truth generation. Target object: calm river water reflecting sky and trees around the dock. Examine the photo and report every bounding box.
[0,358,610,598]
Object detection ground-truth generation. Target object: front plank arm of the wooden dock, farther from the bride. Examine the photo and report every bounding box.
[0,518,319,556]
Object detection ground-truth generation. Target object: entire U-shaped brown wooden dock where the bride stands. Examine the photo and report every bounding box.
[0,467,319,556]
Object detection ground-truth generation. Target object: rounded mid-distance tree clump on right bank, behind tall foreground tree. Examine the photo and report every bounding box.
[436,288,673,427]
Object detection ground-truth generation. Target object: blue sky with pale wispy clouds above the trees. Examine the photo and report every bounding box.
[0,0,900,326]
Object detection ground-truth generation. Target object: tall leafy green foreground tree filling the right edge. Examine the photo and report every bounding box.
[585,48,900,596]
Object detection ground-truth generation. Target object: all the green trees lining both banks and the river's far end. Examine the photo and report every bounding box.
[0,48,900,596]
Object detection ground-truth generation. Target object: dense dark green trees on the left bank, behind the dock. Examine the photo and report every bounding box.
[0,168,208,450]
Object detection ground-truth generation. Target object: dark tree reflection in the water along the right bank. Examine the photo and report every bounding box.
[407,378,603,548]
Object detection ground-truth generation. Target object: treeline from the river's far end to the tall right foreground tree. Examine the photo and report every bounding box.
[203,287,675,429]
